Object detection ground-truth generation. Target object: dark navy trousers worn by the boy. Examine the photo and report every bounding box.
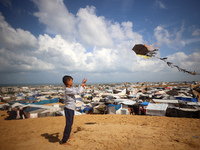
[62,108,74,143]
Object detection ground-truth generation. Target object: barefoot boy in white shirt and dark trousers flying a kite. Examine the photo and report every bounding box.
[62,76,87,145]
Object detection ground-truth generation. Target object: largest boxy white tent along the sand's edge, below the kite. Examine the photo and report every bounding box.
[146,103,168,116]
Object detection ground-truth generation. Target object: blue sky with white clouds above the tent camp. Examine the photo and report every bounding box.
[0,0,200,84]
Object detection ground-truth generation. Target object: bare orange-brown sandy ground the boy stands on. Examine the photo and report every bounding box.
[0,111,200,150]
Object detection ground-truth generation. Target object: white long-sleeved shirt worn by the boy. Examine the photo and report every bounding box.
[65,85,83,110]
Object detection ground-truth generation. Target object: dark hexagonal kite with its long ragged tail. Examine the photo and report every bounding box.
[132,44,200,75]
